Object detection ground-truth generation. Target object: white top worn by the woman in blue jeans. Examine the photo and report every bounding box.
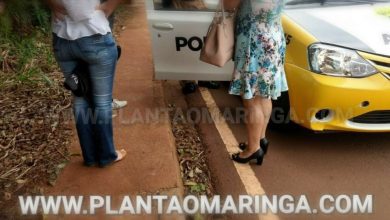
[52,0,111,40]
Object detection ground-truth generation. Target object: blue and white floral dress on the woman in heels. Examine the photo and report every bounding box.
[229,0,288,99]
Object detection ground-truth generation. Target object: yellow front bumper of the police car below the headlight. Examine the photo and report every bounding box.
[286,64,390,132]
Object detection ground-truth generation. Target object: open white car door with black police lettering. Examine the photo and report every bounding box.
[145,0,233,81]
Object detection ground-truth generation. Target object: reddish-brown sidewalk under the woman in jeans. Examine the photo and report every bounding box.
[45,0,183,219]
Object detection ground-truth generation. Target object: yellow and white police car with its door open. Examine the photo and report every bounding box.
[146,0,390,132]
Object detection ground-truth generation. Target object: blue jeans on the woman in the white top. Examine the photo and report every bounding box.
[53,34,118,166]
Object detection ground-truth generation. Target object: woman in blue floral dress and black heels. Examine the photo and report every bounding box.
[225,0,287,165]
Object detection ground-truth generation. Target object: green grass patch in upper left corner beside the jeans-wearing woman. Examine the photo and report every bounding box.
[0,0,57,90]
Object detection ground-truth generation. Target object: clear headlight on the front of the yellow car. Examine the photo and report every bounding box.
[309,44,378,78]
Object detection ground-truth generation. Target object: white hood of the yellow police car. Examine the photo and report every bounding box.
[286,3,390,56]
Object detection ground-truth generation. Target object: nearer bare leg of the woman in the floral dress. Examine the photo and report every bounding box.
[240,97,264,158]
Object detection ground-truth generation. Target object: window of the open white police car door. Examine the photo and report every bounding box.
[153,0,218,11]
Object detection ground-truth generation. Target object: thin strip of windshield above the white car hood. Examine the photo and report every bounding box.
[286,0,390,6]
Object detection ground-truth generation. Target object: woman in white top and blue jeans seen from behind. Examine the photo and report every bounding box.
[47,0,126,167]
